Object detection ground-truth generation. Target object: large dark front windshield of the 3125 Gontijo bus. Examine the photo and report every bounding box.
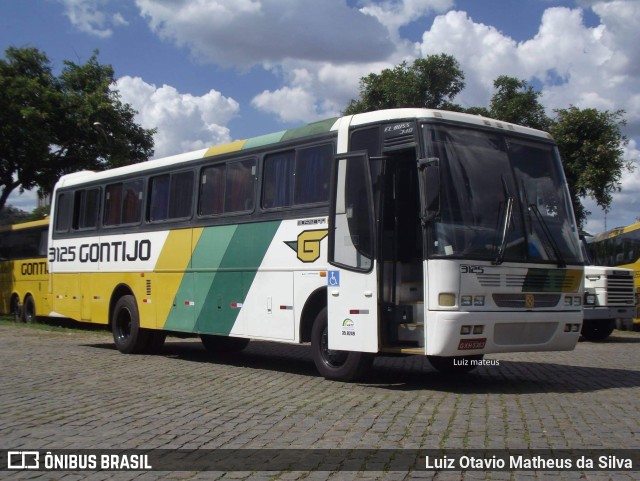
[423,124,583,267]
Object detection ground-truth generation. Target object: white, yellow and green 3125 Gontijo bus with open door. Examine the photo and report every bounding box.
[49,109,583,380]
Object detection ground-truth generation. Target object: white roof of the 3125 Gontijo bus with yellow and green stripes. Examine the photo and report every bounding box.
[57,108,551,187]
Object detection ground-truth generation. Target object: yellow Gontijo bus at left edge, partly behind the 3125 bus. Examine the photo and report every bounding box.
[0,219,51,322]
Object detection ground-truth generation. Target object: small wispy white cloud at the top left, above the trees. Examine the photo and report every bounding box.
[59,0,128,38]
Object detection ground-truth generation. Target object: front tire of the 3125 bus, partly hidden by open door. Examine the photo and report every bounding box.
[311,307,374,382]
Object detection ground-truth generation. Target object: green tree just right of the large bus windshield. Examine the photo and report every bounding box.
[550,105,633,227]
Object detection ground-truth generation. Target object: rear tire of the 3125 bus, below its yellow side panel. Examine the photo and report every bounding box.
[111,295,149,354]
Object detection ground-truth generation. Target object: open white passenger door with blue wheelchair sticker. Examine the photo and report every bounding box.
[327,153,378,352]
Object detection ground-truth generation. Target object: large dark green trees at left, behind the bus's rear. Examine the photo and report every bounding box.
[0,47,155,208]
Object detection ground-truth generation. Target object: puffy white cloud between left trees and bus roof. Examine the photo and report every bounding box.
[116,76,239,157]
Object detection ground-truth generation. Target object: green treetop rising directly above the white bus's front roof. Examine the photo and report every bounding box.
[344,54,465,115]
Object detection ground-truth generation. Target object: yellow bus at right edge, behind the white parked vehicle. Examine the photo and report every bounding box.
[588,222,640,330]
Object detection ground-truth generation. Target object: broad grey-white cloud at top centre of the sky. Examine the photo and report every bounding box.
[136,0,394,68]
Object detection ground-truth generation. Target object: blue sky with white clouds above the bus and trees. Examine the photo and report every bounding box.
[0,0,640,233]
